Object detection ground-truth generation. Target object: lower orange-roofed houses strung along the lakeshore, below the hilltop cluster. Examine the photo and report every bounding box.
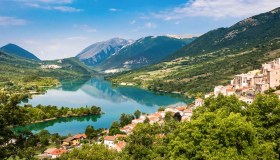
[38,99,203,159]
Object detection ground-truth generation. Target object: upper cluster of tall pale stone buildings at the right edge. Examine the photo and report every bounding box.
[205,58,280,104]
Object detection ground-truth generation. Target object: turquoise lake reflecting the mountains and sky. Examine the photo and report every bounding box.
[18,78,193,135]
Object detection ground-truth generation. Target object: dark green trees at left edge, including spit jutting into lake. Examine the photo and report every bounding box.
[0,92,101,159]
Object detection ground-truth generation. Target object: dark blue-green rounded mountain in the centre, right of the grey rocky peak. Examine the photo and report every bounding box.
[96,36,195,72]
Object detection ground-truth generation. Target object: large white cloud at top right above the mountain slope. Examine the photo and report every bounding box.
[153,0,280,20]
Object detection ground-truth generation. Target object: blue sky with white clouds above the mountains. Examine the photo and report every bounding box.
[0,0,280,60]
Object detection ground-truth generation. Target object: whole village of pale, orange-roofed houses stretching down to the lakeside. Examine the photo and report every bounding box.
[38,58,280,159]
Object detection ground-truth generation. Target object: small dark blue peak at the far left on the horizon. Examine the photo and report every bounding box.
[0,43,40,61]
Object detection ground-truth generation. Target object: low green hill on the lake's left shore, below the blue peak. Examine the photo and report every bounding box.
[0,51,92,93]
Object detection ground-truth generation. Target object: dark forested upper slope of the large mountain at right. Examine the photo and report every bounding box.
[169,8,280,60]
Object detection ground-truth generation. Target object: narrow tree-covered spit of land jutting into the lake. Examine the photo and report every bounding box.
[23,105,101,123]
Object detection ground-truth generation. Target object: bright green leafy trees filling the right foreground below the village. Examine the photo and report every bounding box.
[61,95,280,160]
